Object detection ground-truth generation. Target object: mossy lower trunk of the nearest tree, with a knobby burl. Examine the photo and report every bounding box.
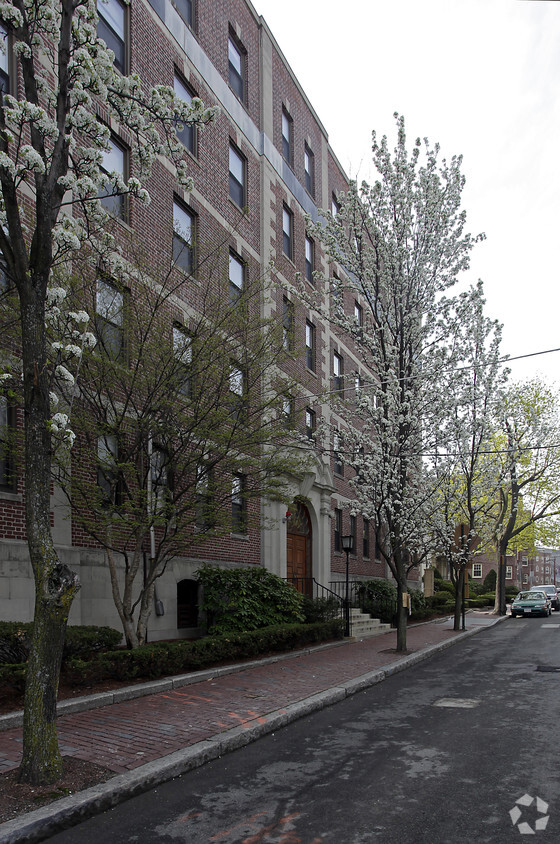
[18,286,79,785]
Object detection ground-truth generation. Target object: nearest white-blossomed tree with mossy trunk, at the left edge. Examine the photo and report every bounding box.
[0,0,215,783]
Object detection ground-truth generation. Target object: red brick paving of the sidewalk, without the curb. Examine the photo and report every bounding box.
[0,622,468,773]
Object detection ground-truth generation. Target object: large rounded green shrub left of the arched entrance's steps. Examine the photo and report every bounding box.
[196,565,304,634]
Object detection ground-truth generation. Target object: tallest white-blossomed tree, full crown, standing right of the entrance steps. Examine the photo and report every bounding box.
[309,115,484,651]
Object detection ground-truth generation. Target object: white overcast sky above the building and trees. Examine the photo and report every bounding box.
[258,0,560,384]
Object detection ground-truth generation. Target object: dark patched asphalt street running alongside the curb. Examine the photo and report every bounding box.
[44,613,560,844]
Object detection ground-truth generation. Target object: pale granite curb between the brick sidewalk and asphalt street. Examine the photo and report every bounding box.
[0,616,506,844]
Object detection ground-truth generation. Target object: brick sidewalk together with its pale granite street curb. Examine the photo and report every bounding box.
[0,612,503,844]
